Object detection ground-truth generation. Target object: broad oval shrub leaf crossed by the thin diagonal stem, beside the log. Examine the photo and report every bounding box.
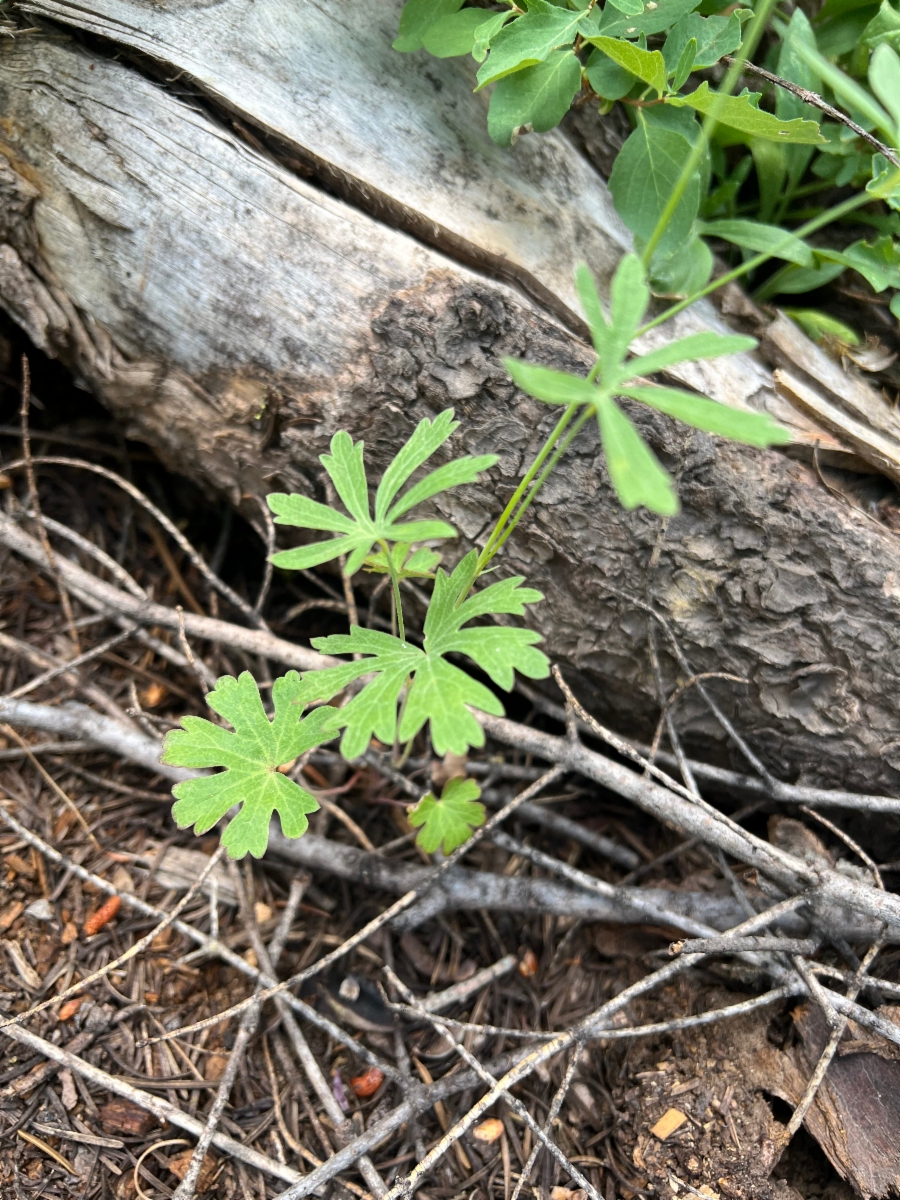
[607,115,706,253]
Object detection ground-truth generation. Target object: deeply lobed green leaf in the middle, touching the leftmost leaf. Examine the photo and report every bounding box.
[304,550,550,758]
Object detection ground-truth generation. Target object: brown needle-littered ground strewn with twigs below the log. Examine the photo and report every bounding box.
[0,319,883,1200]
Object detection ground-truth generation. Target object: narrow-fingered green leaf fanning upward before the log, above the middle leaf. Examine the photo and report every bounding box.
[266,408,497,575]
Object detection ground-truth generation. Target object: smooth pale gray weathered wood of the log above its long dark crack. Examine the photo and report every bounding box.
[23,0,808,422]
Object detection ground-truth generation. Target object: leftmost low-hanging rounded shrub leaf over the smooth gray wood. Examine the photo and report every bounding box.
[487,49,581,146]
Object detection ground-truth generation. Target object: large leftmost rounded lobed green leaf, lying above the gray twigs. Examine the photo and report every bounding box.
[160,671,335,858]
